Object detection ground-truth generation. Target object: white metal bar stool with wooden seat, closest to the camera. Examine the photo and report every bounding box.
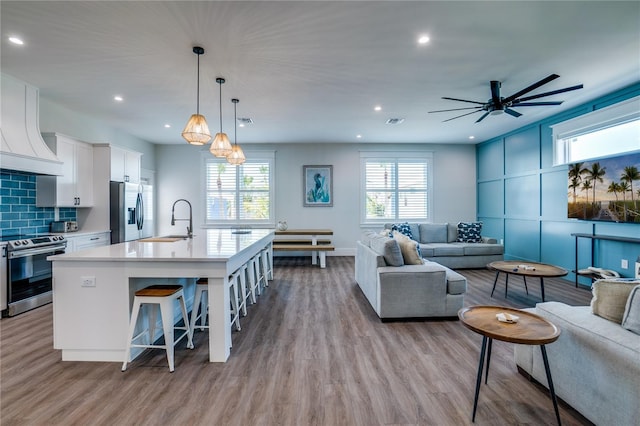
[122,285,193,372]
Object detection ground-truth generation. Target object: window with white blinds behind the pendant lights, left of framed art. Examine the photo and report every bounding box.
[205,155,274,226]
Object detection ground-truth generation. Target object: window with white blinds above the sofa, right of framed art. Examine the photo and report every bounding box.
[361,153,432,223]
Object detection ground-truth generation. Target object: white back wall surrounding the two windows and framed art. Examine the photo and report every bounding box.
[156,144,476,255]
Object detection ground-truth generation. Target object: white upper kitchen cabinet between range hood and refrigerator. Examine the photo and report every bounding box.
[36,133,93,207]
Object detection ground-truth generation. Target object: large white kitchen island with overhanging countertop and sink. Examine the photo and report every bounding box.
[49,229,274,362]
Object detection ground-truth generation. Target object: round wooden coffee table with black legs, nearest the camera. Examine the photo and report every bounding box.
[458,306,560,425]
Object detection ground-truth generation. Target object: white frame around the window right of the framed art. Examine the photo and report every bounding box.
[359,151,434,227]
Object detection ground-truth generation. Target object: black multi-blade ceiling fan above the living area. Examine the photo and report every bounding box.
[429,74,582,123]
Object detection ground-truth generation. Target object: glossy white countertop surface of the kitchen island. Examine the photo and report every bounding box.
[48,229,274,262]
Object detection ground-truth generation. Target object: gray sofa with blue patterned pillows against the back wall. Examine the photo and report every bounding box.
[385,222,504,269]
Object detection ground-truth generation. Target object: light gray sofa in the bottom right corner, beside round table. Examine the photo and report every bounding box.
[514,302,640,426]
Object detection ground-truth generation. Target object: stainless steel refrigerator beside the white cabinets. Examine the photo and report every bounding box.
[110,182,153,244]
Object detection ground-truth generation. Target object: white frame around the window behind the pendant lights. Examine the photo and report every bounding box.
[200,150,275,228]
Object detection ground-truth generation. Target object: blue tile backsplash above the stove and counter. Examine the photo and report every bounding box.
[0,169,76,236]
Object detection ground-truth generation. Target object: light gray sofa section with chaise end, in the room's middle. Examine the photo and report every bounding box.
[355,231,467,319]
